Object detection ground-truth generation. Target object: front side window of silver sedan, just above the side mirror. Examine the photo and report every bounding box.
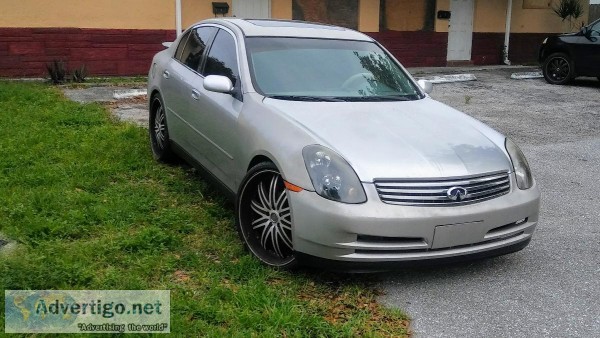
[203,30,240,91]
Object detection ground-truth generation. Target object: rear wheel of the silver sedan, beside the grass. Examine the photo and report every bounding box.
[148,94,176,163]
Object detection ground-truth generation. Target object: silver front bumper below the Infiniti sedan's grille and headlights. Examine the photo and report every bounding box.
[290,175,540,264]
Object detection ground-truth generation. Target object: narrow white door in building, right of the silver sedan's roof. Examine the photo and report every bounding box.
[447,0,473,61]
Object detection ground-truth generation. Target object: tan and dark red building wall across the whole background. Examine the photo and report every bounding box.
[0,0,589,76]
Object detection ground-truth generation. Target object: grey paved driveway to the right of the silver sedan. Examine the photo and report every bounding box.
[381,69,600,337]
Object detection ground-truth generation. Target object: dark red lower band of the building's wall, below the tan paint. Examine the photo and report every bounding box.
[0,28,546,77]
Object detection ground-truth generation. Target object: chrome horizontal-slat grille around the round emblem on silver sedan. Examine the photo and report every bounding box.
[375,171,510,206]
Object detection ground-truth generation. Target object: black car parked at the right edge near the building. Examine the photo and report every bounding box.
[539,20,600,84]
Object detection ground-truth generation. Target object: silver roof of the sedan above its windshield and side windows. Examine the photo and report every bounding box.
[198,18,373,41]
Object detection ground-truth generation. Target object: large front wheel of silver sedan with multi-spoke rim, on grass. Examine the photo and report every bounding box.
[236,162,298,269]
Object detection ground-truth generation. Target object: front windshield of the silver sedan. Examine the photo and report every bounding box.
[246,37,421,102]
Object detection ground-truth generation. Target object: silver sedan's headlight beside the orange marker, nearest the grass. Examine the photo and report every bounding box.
[302,145,367,203]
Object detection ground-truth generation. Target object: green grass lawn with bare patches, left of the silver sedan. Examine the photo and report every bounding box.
[0,82,408,337]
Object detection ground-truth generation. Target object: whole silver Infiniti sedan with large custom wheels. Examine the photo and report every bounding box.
[148,18,540,270]
